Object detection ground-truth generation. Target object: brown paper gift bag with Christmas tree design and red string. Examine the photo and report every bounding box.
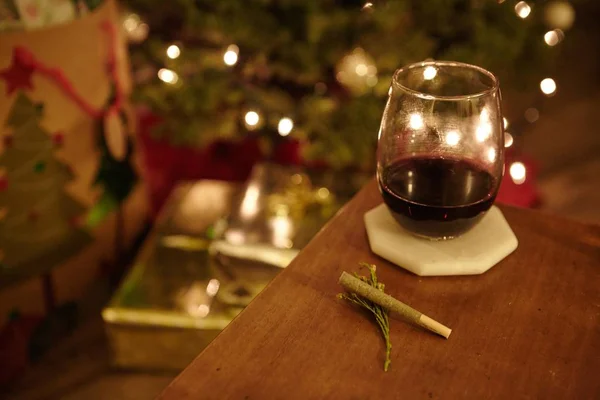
[0,0,143,325]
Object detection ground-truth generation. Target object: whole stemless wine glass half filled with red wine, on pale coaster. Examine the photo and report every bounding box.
[377,61,504,239]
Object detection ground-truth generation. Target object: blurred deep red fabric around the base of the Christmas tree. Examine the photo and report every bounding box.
[138,110,541,212]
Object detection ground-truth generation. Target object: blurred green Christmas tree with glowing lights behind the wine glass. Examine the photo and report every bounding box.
[124,0,562,168]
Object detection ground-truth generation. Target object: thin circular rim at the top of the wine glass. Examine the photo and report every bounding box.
[392,60,500,101]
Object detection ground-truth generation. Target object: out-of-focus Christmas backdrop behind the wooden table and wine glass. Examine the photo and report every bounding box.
[0,0,600,399]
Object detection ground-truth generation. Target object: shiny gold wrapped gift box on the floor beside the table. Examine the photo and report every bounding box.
[102,164,367,369]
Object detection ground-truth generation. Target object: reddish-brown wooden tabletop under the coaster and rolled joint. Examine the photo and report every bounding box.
[161,182,600,399]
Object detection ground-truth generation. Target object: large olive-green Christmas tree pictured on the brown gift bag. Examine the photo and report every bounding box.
[0,92,92,269]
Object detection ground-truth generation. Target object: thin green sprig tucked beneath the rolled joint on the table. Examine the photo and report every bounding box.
[337,262,392,371]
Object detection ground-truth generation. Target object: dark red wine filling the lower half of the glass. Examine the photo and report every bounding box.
[378,156,498,239]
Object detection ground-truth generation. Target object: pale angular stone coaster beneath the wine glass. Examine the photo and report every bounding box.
[365,204,518,276]
